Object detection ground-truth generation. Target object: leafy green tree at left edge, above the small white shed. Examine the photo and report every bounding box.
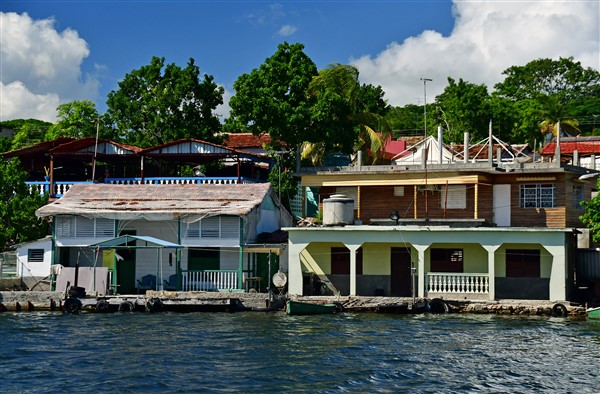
[0,157,48,250]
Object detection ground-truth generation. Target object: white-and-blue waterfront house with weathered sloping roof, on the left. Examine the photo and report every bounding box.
[36,183,292,294]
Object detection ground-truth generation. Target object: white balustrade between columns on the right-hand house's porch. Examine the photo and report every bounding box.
[426,272,490,294]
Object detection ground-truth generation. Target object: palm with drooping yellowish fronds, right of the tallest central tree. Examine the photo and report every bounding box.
[302,64,391,165]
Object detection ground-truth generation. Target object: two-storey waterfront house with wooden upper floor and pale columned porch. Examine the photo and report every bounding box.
[285,132,595,300]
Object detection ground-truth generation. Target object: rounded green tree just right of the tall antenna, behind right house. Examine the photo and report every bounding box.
[433,78,492,142]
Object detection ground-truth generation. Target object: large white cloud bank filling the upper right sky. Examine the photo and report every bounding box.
[351,0,600,106]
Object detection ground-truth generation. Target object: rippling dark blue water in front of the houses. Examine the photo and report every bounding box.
[0,312,600,393]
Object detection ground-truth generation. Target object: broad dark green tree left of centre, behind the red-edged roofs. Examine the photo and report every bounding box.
[107,57,224,147]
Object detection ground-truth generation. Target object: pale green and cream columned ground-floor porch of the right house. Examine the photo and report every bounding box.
[286,226,573,300]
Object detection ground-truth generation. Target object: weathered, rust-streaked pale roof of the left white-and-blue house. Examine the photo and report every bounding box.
[36,183,272,222]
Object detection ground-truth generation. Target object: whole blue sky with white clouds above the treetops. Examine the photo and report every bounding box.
[0,0,600,122]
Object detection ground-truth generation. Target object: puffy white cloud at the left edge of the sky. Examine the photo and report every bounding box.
[0,12,99,121]
